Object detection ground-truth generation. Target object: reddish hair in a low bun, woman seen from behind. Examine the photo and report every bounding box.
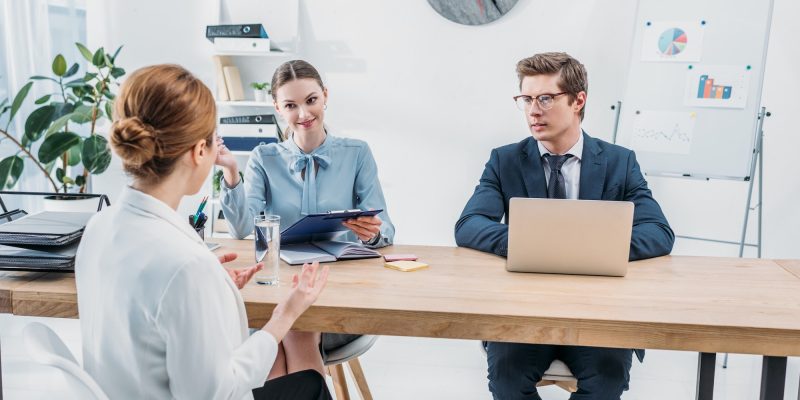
[110,64,217,182]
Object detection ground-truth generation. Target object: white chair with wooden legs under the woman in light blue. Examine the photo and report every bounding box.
[325,335,378,400]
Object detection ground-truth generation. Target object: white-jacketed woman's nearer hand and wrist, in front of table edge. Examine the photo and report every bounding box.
[262,262,329,342]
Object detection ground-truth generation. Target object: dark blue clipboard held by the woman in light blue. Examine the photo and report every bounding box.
[281,209,383,244]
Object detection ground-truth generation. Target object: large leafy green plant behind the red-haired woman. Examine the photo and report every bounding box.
[0,43,125,211]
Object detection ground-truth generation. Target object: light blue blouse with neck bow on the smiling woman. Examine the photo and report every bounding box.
[220,134,394,247]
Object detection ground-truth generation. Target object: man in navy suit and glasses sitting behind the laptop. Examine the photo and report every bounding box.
[455,53,675,400]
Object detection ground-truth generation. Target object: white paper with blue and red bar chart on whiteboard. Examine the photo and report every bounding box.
[684,65,751,108]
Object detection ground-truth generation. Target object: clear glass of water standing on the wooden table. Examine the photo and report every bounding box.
[254,214,281,285]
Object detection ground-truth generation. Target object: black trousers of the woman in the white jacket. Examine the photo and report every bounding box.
[253,369,332,400]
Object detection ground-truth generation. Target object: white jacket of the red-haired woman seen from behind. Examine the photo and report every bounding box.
[75,188,278,399]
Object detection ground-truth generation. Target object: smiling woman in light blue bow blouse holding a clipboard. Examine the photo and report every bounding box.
[216,60,394,364]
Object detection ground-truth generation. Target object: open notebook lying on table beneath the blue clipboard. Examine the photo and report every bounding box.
[281,240,381,265]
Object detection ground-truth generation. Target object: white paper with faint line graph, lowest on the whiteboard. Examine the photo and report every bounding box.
[631,111,697,154]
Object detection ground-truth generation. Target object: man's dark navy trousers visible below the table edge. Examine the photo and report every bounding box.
[485,342,633,400]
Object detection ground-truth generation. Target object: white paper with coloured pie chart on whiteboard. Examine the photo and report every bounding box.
[642,21,705,62]
